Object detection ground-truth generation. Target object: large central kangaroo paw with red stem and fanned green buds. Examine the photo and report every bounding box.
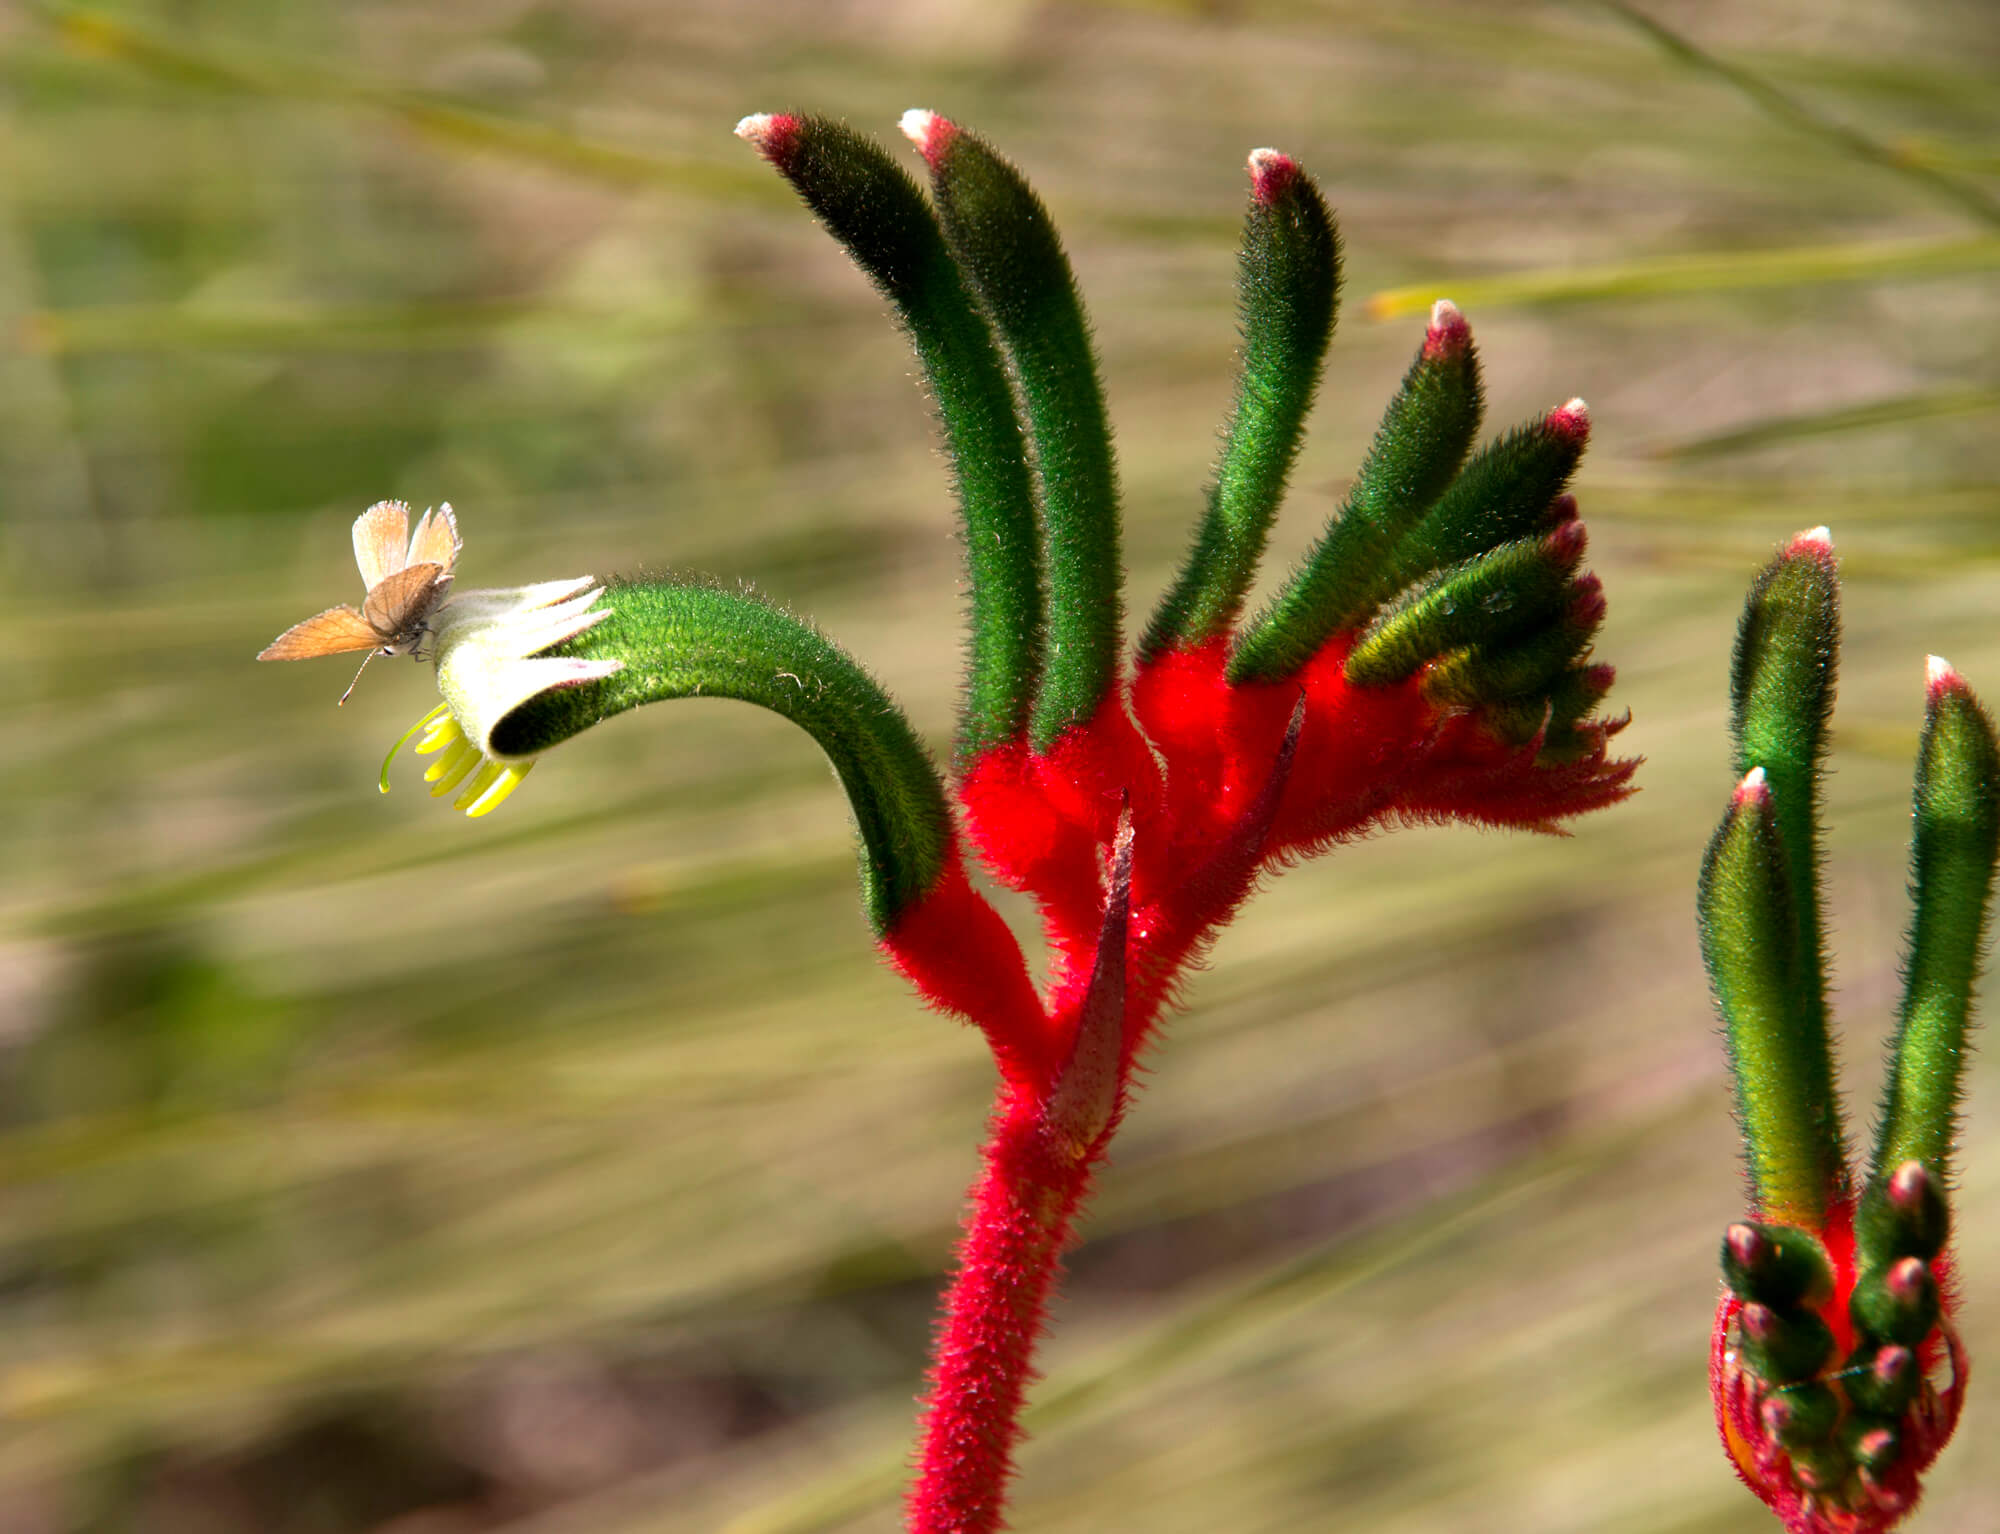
[724,112,1636,1534]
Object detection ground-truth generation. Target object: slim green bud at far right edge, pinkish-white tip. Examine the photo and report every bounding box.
[1874,656,2000,1180]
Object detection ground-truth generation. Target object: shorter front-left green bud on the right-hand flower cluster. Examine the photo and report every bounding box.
[1698,768,1842,1228]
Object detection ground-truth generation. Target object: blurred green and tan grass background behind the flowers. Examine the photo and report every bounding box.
[0,0,2000,1534]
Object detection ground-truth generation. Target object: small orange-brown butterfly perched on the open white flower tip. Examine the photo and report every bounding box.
[258,500,464,702]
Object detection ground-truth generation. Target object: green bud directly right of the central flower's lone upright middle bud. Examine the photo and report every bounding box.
[1230,300,1480,682]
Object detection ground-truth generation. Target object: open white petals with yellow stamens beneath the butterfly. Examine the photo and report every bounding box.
[382,576,624,816]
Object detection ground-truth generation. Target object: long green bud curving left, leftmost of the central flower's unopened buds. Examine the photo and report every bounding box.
[736,116,1042,760]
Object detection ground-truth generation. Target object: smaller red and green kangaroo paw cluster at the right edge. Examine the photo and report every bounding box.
[1700,528,2000,1534]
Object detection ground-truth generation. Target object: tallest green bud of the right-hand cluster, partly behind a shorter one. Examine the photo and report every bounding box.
[1730,528,1846,1178]
